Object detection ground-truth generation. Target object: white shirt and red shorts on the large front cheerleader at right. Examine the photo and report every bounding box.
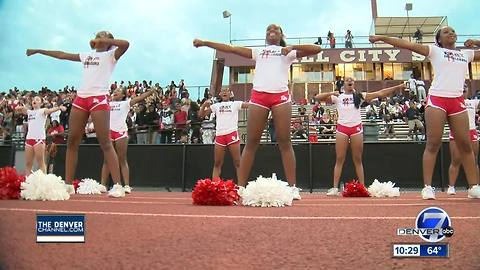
[427,45,474,116]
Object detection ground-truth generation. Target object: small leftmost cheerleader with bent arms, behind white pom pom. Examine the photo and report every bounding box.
[15,96,66,176]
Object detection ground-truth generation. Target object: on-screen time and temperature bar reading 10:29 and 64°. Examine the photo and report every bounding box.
[392,243,450,258]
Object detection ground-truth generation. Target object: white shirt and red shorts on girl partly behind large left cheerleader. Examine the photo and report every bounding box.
[109,99,130,141]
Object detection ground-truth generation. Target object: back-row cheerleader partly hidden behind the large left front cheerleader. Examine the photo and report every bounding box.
[101,87,155,193]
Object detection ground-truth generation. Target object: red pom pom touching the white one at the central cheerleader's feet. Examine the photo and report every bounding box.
[192,178,239,205]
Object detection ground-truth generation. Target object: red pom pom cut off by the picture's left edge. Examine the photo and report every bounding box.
[0,167,25,200]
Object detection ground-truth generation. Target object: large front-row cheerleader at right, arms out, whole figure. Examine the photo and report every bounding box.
[370,26,480,200]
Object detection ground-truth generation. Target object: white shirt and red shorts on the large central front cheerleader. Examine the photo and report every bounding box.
[250,45,297,109]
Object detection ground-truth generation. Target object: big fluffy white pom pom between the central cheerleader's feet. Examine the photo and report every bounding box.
[239,173,293,207]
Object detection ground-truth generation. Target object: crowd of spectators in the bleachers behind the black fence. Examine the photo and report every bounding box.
[0,77,478,144]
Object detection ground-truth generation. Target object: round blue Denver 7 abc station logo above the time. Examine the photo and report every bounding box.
[397,207,454,243]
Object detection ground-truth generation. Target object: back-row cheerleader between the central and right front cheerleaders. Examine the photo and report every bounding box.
[316,77,404,196]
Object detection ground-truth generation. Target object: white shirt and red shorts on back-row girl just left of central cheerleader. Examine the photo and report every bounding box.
[210,101,243,146]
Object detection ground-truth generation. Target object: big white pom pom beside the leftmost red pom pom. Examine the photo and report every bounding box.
[20,170,70,201]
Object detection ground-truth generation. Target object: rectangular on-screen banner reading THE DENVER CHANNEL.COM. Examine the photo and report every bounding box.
[36,214,85,243]
